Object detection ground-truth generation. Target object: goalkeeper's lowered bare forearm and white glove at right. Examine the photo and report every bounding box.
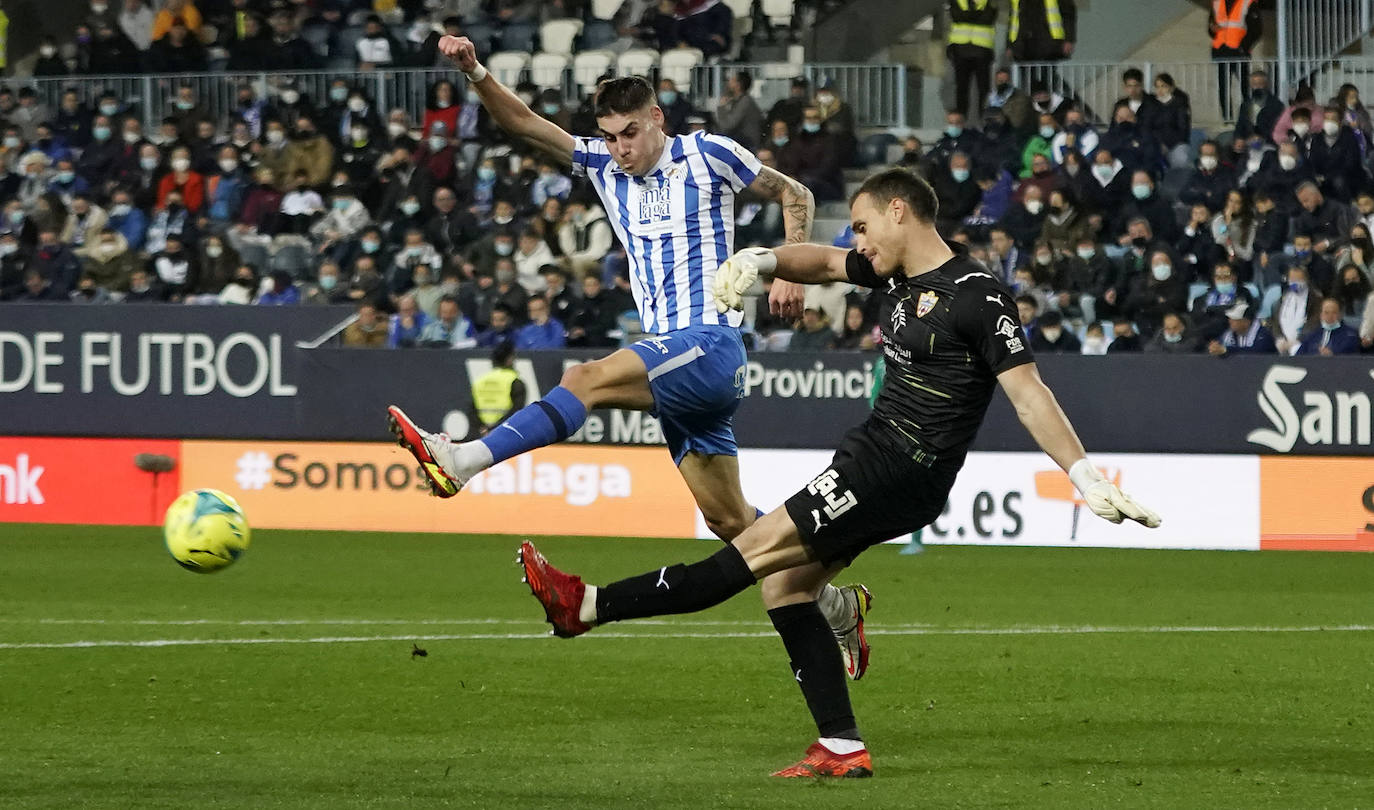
[998,362,1160,529]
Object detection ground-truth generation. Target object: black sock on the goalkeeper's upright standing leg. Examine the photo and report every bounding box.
[768,601,863,740]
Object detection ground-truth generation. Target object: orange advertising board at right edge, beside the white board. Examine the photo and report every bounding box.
[1260,456,1374,552]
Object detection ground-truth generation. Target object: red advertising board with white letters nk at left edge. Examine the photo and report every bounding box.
[0,437,181,526]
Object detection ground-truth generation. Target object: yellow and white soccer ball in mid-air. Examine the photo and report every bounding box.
[162,489,251,574]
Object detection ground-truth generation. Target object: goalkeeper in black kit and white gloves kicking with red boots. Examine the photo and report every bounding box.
[521,169,1160,777]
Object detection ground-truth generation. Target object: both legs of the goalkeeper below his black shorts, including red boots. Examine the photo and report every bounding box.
[521,508,872,777]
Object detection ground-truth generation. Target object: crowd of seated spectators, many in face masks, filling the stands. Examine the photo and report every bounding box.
[0,0,1374,356]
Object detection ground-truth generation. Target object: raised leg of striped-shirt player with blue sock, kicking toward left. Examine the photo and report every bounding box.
[387,349,654,498]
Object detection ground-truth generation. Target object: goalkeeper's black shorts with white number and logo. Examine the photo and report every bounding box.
[783,420,962,566]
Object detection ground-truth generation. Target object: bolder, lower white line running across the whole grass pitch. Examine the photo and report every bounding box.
[0,622,1374,649]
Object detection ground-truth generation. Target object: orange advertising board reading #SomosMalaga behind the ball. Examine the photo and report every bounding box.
[181,441,697,537]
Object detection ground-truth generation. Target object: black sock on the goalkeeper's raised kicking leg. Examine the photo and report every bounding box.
[596,545,758,628]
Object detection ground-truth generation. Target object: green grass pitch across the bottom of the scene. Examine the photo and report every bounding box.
[0,527,1374,810]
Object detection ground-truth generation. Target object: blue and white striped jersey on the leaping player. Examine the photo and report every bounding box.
[573,132,763,335]
